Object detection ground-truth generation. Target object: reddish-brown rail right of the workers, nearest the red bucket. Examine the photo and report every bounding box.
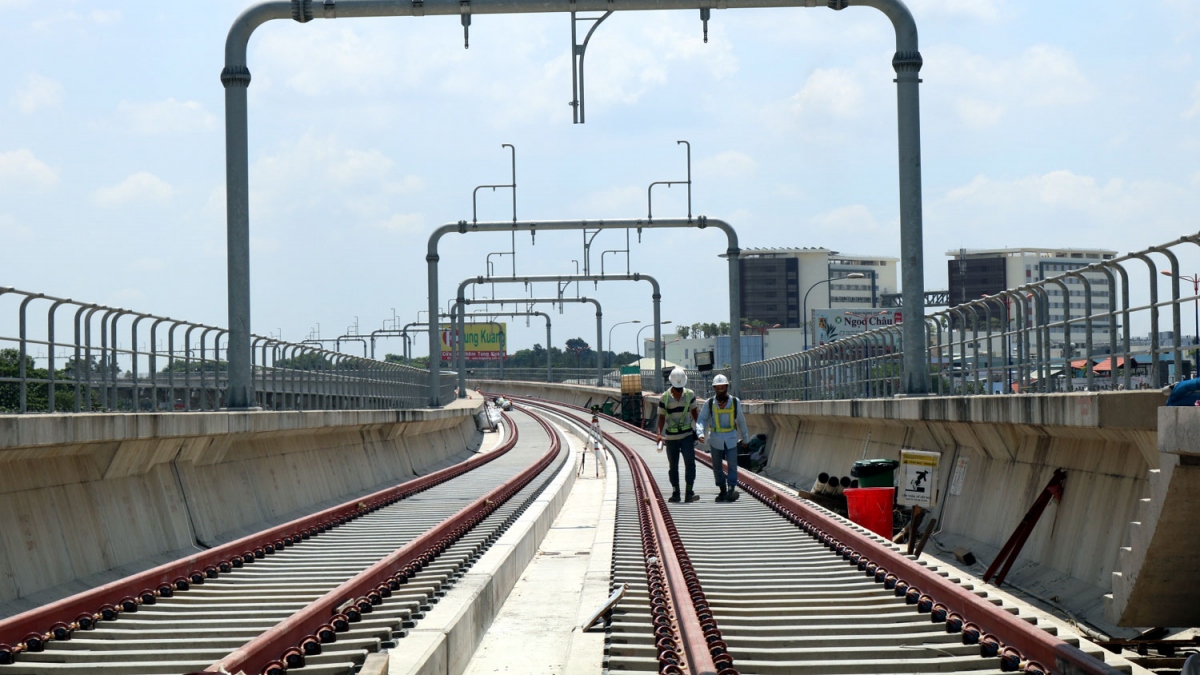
[516,396,1120,675]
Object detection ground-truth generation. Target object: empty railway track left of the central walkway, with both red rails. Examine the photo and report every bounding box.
[0,403,566,675]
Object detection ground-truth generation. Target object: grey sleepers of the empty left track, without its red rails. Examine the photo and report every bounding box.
[0,414,566,675]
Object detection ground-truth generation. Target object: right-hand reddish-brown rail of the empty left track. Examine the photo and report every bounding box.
[205,401,562,675]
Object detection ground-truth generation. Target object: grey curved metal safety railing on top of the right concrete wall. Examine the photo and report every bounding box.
[742,234,1200,400]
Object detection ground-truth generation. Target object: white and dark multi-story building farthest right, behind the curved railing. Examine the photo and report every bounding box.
[946,249,1117,347]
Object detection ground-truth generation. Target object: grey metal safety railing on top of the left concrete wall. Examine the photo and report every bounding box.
[0,287,441,413]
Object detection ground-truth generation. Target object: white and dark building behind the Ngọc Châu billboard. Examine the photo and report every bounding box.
[739,247,899,328]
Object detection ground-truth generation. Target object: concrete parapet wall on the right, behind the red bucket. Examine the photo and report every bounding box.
[484,382,1161,628]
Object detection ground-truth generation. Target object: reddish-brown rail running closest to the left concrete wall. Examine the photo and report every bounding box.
[0,410,520,664]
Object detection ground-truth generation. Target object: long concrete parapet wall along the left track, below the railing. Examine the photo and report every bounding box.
[0,400,481,616]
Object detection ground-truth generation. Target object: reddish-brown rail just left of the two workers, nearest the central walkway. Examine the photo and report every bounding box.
[514,396,738,675]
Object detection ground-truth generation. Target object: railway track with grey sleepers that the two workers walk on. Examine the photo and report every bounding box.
[516,396,1118,675]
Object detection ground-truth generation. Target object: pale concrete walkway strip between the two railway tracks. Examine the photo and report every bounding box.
[466,438,617,675]
